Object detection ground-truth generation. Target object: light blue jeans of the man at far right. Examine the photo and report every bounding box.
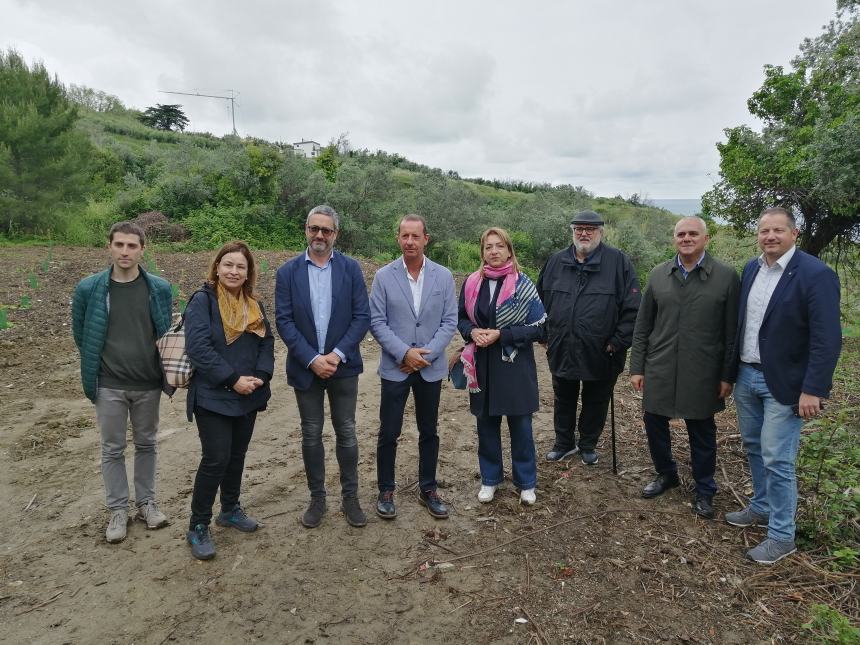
[735,363,803,542]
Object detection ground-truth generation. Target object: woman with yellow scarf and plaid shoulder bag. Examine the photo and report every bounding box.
[185,242,275,560]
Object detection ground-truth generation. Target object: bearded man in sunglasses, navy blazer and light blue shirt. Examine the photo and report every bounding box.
[275,205,370,528]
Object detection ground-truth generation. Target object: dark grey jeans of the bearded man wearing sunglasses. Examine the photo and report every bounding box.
[295,376,358,497]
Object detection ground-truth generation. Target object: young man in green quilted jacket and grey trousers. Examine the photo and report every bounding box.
[72,222,173,543]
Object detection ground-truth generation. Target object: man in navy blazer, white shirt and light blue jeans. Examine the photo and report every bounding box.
[726,208,842,564]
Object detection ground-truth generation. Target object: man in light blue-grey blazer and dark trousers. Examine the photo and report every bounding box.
[370,215,457,519]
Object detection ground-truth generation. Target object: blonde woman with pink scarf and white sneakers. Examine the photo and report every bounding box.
[457,228,546,505]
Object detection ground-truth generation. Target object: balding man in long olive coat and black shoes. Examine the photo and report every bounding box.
[630,217,740,519]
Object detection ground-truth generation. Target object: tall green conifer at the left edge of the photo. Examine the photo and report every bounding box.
[0,49,93,234]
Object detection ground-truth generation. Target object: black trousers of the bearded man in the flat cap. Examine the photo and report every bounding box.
[552,376,618,452]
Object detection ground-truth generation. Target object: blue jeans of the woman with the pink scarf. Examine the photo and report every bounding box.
[476,414,537,490]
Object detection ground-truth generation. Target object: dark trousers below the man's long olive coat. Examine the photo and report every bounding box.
[644,412,717,497]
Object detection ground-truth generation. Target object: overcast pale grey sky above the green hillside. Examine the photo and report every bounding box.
[0,0,836,199]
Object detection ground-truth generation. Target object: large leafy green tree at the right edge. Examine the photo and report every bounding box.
[702,0,860,256]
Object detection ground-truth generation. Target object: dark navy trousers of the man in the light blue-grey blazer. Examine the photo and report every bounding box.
[376,372,442,491]
